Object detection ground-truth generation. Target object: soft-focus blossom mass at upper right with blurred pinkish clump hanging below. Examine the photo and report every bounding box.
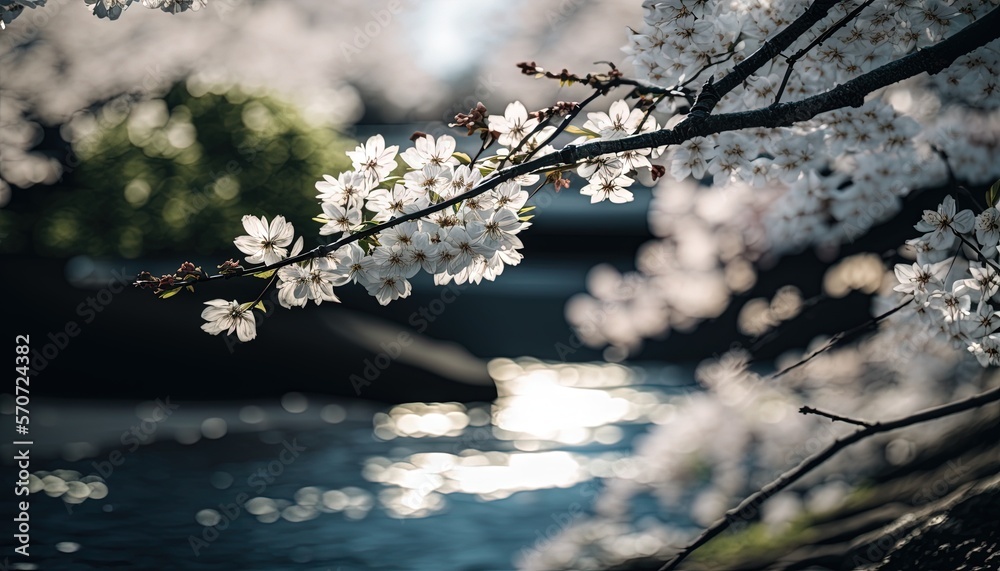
[567,0,1000,350]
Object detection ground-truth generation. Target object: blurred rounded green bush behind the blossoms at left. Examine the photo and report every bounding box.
[0,84,355,256]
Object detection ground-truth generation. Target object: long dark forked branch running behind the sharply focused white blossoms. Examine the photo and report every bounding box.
[141,6,1000,289]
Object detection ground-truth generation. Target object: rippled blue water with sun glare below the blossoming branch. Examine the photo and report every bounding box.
[8,359,683,571]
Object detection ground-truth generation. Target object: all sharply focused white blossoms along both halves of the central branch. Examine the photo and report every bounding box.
[194,94,662,340]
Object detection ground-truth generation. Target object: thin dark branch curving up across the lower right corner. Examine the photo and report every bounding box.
[660,387,1000,571]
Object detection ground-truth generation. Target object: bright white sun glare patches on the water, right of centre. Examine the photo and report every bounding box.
[362,359,673,518]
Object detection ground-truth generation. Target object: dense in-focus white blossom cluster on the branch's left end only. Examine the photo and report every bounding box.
[202,125,539,340]
